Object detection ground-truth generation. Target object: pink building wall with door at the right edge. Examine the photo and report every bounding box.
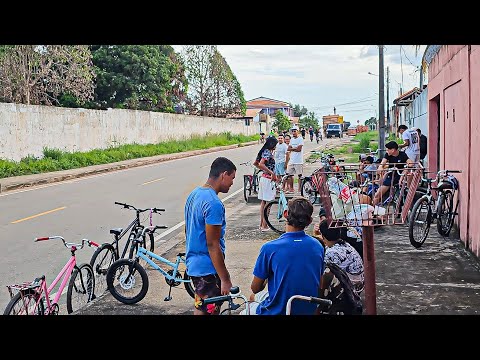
[428,45,480,257]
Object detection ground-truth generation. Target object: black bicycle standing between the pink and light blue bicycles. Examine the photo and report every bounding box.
[90,202,165,295]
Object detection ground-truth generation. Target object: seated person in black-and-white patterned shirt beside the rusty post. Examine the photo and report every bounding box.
[314,220,364,293]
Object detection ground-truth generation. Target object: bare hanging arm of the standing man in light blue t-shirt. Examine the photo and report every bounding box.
[205,224,232,295]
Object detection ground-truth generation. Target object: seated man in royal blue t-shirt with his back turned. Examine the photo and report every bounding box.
[240,197,324,315]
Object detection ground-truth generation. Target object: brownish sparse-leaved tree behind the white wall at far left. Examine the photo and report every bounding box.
[0,45,95,105]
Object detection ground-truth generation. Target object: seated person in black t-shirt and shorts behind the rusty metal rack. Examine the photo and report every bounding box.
[372,141,413,206]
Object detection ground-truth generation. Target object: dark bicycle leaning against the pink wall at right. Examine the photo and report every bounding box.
[408,170,462,248]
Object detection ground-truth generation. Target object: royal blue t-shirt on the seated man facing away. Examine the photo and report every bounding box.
[253,231,324,315]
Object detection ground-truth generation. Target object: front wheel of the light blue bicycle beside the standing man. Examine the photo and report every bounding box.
[107,259,148,305]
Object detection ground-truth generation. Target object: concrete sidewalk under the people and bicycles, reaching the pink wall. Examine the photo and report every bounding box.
[76,155,480,315]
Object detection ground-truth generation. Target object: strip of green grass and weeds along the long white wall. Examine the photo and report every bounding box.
[0,132,260,178]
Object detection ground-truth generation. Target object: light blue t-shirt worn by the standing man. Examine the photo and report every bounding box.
[185,187,226,276]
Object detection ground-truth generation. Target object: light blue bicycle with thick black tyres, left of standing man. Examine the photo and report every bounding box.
[106,226,195,305]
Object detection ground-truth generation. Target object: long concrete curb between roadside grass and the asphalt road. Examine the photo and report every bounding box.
[0,141,258,193]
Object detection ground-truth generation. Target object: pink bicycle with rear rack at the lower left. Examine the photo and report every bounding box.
[3,236,98,315]
